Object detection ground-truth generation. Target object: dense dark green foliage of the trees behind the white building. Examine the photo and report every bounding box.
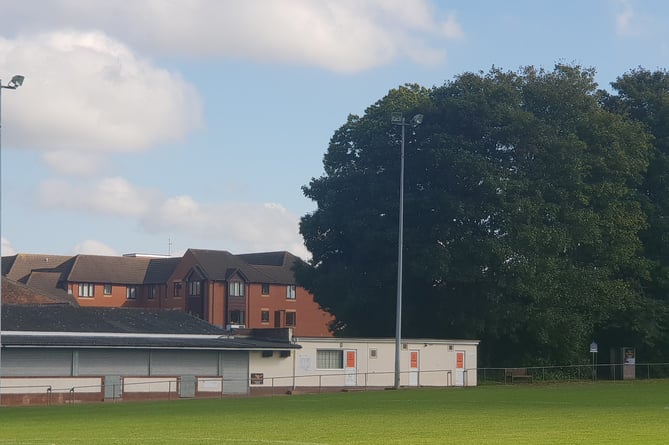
[297,65,669,366]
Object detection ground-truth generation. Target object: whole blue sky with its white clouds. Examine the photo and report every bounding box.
[0,0,669,258]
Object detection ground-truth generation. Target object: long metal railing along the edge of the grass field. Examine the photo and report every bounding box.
[0,363,669,405]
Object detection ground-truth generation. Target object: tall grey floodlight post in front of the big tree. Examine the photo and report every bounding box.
[390,113,423,389]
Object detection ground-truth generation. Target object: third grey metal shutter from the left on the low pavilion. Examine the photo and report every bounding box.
[151,351,218,376]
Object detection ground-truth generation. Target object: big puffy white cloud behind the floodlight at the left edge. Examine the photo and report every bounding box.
[0,31,202,158]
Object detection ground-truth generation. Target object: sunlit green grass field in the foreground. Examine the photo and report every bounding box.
[0,380,669,445]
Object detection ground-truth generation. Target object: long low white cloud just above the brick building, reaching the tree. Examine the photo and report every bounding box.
[40,177,309,259]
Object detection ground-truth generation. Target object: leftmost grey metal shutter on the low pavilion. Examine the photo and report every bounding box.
[2,348,72,377]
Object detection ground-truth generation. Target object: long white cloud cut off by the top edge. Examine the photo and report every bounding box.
[0,0,463,72]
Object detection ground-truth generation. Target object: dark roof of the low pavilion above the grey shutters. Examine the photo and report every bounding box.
[2,305,299,350]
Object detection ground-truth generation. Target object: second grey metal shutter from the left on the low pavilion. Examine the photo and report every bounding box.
[78,349,149,376]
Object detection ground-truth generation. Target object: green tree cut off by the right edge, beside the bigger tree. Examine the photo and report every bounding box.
[605,68,669,360]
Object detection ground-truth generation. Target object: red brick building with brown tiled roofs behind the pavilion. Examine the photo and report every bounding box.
[2,249,333,337]
